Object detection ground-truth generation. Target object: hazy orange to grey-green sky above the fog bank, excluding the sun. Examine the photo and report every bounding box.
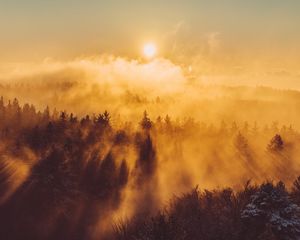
[0,0,300,86]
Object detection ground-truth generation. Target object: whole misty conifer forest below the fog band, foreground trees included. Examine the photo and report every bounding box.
[0,98,300,240]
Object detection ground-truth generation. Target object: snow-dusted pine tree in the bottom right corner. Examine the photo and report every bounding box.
[241,182,300,240]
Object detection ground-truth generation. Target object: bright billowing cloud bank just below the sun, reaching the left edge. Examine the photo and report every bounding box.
[0,55,186,117]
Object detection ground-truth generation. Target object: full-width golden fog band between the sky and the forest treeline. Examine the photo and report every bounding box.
[0,55,300,126]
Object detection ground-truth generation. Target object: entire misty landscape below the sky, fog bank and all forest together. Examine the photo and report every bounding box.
[0,59,300,240]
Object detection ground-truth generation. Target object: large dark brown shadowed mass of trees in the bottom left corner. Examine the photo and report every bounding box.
[0,145,128,239]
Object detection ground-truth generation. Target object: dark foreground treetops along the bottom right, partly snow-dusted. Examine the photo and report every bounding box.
[115,181,300,240]
